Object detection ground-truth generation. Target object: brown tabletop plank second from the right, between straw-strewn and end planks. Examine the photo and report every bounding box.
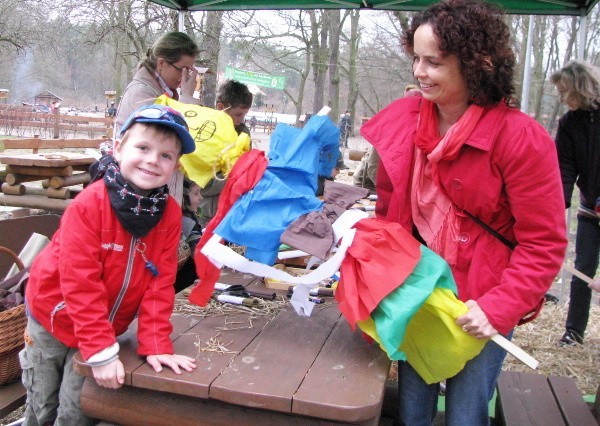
[209,304,340,413]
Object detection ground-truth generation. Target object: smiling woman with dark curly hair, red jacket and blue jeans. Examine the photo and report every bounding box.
[361,0,567,426]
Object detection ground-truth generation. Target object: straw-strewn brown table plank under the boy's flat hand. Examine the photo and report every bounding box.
[132,314,267,399]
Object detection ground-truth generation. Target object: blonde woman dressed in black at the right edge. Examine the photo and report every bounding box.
[550,61,600,346]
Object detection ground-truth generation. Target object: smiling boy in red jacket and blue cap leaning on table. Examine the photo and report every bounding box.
[19,105,196,425]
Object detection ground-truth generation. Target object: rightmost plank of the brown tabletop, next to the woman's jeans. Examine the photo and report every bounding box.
[292,318,391,423]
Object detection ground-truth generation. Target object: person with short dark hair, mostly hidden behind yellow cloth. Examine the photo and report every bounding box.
[200,80,253,227]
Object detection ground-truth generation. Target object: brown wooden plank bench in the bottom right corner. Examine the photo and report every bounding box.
[495,371,598,426]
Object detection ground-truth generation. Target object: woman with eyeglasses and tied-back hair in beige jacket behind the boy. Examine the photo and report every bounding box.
[114,32,200,135]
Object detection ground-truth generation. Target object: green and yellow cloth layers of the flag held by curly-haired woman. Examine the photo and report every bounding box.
[357,246,487,384]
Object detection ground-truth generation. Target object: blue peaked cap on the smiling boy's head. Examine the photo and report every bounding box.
[119,105,196,154]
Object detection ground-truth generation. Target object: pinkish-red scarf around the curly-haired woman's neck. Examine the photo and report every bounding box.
[411,99,484,266]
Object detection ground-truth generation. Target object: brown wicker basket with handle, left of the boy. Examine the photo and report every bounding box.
[0,246,27,385]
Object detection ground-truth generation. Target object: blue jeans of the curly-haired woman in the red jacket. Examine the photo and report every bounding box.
[395,332,512,426]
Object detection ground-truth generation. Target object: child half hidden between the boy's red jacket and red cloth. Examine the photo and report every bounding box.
[175,178,202,293]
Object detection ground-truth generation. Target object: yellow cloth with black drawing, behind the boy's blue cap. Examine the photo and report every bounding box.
[156,95,250,188]
